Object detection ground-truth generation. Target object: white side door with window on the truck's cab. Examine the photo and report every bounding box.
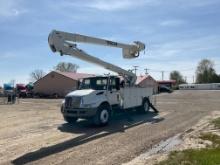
[107,77,120,105]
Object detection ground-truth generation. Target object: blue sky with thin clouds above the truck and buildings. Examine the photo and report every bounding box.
[0,0,220,85]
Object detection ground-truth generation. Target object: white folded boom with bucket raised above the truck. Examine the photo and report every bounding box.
[48,30,145,85]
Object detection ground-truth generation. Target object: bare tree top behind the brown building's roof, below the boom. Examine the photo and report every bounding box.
[54,62,79,73]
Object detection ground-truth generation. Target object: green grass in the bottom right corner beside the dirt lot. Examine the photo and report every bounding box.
[158,122,220,165]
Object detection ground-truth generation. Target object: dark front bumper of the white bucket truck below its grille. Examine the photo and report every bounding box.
[61,107,97,118]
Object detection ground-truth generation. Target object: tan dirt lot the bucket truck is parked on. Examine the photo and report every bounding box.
[0,91,220,164]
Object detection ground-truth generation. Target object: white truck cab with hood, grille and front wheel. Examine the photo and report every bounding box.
[61,76,120,125]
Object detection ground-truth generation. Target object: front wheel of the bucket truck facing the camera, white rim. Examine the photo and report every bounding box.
[93,104,111,126]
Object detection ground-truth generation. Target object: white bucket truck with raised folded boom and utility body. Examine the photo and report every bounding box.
[48,30,156,125]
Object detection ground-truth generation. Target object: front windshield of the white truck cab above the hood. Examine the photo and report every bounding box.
[79,77,108,90]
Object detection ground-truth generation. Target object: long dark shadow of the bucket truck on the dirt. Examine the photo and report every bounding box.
[12,111,164,164]
